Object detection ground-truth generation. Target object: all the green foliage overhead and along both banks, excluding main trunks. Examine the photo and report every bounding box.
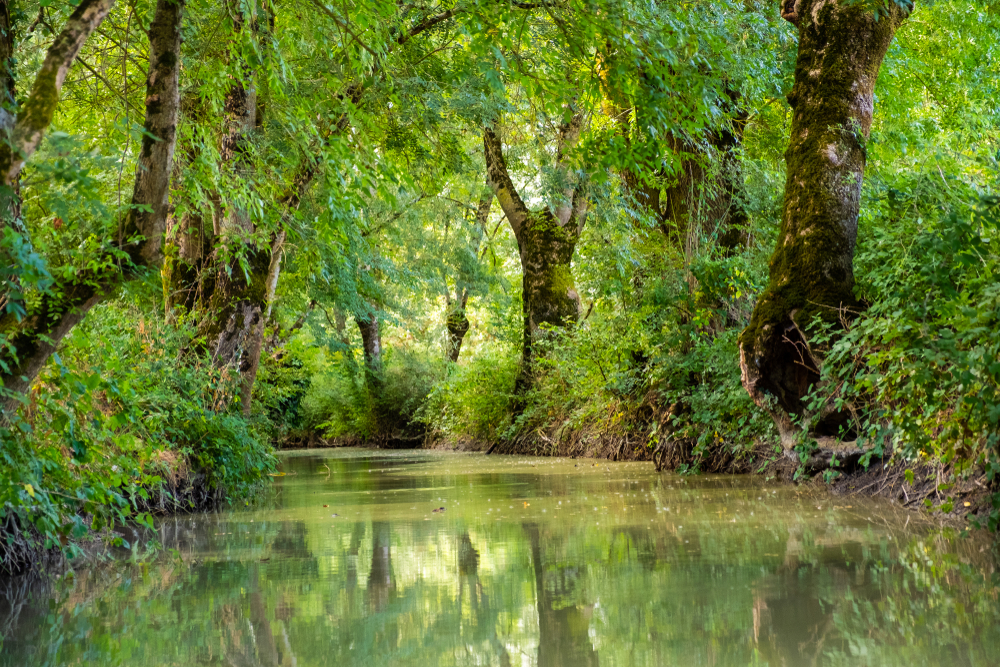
[0,0,1000,576]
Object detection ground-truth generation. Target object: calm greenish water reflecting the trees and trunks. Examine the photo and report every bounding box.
[0,450,1000,667]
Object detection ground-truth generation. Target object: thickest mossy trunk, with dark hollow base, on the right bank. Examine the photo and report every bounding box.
[739,0,905,448]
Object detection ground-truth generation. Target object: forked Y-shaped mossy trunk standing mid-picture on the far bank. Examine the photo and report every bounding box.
[483,116,587,392]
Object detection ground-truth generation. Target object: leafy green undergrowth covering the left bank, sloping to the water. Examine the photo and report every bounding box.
[0,285,274,566]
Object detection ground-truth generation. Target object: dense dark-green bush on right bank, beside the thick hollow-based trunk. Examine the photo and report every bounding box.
[814,199,1000,521]
